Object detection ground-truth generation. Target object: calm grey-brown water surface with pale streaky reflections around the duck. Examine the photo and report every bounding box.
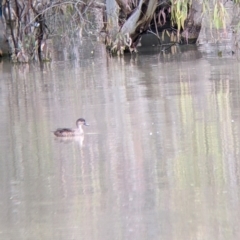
[0,45,240,240]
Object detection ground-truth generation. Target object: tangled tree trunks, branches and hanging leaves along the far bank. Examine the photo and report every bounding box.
[0,0,240,63]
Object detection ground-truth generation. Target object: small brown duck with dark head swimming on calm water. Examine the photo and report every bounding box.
[53,118,89,137]
